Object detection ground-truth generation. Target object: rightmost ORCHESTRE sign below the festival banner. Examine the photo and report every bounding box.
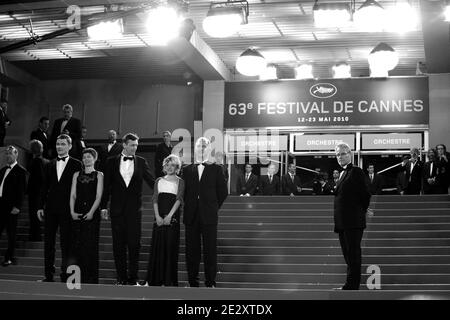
[361,133,422,150]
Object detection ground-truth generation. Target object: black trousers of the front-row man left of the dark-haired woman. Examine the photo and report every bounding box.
[44,212,75,282]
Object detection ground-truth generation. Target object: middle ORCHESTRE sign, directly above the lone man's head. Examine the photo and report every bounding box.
[292,134,355,152]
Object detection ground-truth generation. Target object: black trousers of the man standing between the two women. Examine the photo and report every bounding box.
[111,212,141,282]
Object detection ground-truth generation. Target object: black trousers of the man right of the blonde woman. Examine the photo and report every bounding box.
[185,221,217,287]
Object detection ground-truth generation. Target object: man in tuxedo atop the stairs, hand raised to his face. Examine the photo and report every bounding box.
[400,148,423,194]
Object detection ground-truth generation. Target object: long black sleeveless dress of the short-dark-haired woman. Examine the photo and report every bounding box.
[72,171,100,283]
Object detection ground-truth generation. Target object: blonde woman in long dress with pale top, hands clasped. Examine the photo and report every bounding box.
[147,155,184,287]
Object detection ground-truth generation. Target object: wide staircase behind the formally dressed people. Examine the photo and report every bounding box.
[0,195,450,291]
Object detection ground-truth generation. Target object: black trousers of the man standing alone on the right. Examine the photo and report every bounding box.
[339,229,364,290]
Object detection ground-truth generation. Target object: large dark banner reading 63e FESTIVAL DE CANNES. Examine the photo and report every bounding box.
[224,77,429,128]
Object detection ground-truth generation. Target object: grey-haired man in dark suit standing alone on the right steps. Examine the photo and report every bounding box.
[334,143,371,290]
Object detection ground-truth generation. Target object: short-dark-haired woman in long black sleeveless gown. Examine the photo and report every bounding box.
[70,148,103,283]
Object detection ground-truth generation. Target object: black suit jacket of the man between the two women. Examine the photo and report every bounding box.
[101,155,155,217]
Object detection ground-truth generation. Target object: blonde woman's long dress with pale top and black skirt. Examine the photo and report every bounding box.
[147,178,184,287]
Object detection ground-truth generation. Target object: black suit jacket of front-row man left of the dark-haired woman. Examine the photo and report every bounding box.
[38,157,81,218]
